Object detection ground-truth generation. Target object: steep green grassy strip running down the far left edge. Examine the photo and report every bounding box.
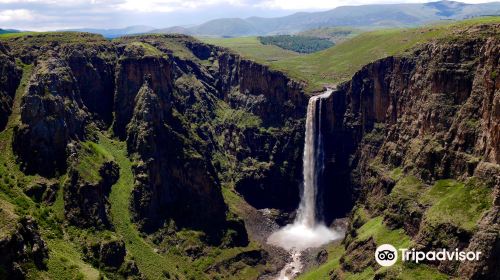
[0,63,100,280]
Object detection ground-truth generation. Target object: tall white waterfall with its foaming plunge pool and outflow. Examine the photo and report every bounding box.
[267,89,342,280]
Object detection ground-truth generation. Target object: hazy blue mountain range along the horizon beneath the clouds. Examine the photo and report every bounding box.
[66,0,500,37]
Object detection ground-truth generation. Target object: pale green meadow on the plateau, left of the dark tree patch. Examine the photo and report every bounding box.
[199,37,300,64]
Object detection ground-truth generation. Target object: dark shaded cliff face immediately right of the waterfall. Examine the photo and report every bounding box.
[322,57,415,221]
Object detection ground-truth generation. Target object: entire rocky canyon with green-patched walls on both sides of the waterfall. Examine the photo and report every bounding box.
[0,20,500,279]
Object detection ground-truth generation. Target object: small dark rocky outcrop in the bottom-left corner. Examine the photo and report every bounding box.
[0,218,49,279]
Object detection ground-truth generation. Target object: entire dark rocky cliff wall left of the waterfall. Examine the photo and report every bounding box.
[0,33,307,277]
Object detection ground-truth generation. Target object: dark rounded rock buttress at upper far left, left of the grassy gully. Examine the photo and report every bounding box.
[13,53,88,177]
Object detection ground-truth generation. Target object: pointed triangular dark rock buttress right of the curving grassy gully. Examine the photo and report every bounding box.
[127,72,226,234]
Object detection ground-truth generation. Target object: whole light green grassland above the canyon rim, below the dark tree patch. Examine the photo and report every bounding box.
[204,17,500,92]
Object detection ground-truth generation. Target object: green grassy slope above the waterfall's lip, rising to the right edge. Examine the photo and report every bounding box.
[270,17,500,91]
